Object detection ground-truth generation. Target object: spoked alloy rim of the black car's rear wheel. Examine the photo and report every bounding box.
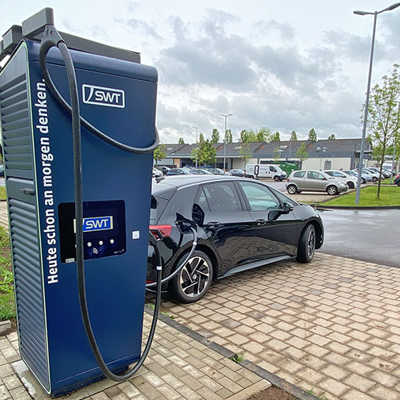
[178,255,212,301]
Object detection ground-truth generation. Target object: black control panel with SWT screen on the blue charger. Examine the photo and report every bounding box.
[58,200,126,263]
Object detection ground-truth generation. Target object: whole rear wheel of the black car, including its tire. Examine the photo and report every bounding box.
[169,250,214,303]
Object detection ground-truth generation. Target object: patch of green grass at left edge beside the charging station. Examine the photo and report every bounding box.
[0,226,15,321]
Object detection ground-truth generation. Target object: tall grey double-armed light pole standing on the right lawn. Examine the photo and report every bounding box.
[353,3,400,204]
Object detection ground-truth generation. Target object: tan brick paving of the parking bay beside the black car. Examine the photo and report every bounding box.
[164,253,400,400]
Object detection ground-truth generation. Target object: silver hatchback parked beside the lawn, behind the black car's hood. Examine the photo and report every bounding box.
[286,170,348,196]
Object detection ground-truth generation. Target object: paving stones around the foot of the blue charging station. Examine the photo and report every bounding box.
[0,314,271,400]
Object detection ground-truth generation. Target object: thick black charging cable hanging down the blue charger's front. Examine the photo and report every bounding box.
[40,25,162,382]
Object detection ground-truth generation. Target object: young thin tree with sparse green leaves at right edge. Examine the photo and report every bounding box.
[363,64,400,199]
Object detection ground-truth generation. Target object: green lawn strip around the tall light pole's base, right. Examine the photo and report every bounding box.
[321,185,400,207]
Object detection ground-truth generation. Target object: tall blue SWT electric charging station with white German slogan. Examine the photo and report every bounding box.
[0,8,183,396]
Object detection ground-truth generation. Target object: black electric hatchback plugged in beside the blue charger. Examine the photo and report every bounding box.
[147,175,324,303]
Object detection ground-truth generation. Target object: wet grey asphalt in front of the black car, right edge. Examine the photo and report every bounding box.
[320,210,400,267]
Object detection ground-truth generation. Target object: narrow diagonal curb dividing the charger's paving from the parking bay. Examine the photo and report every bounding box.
[144,304,320,400]
